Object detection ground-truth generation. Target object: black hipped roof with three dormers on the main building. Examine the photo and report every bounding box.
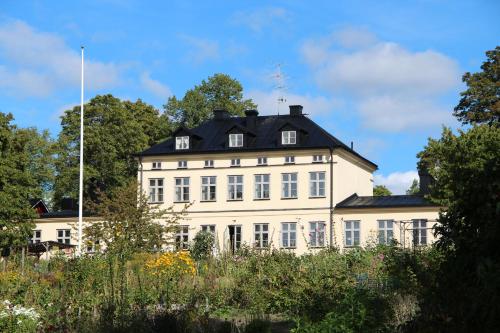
[137,111,377,169]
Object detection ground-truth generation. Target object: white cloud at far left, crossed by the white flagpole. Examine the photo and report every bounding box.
[0,21,120,97]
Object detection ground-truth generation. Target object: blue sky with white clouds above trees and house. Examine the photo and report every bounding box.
[0,0,500,193]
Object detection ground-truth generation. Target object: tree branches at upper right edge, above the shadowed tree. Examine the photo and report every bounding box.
[453,46,500,125]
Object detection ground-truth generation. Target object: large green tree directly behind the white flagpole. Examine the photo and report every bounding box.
[54,95,171,203]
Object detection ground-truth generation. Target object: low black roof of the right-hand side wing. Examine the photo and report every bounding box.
[335,193,436,208]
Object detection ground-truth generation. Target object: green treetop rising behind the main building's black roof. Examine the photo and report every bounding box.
[164,74,257,128]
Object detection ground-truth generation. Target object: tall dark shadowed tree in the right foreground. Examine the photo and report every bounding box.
[419,125,500,332]
